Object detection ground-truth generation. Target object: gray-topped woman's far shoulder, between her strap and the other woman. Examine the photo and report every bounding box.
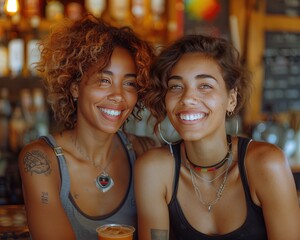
[127,133,160,156]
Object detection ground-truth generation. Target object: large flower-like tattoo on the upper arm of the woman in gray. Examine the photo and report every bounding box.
[24,150,51,175]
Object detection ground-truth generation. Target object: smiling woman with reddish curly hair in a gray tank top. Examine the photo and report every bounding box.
[19,15,156,240]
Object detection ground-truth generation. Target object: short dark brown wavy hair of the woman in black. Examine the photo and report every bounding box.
[144,35,252,131]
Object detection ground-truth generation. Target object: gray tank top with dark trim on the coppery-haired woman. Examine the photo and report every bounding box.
[42,131,137,240]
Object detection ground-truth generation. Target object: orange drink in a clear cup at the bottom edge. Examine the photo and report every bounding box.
[96,224,135,240]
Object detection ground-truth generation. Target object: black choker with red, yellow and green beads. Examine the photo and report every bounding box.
[185,135,232,172]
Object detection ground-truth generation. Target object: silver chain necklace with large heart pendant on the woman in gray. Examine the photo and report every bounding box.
[71,135,114,192]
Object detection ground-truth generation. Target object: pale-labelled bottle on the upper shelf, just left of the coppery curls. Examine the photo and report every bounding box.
[26,16,40,76]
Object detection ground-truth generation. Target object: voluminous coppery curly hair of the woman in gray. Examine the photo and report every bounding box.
[37,14,154,129]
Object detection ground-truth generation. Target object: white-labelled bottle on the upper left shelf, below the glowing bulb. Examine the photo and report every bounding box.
[8,15,25,77]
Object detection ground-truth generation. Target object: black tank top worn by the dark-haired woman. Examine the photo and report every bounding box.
[169,137,268,240]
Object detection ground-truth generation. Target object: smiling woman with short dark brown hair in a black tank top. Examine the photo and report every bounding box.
[135,35,300,240]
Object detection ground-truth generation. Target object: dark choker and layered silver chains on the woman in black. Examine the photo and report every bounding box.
[185,135,232,212]
